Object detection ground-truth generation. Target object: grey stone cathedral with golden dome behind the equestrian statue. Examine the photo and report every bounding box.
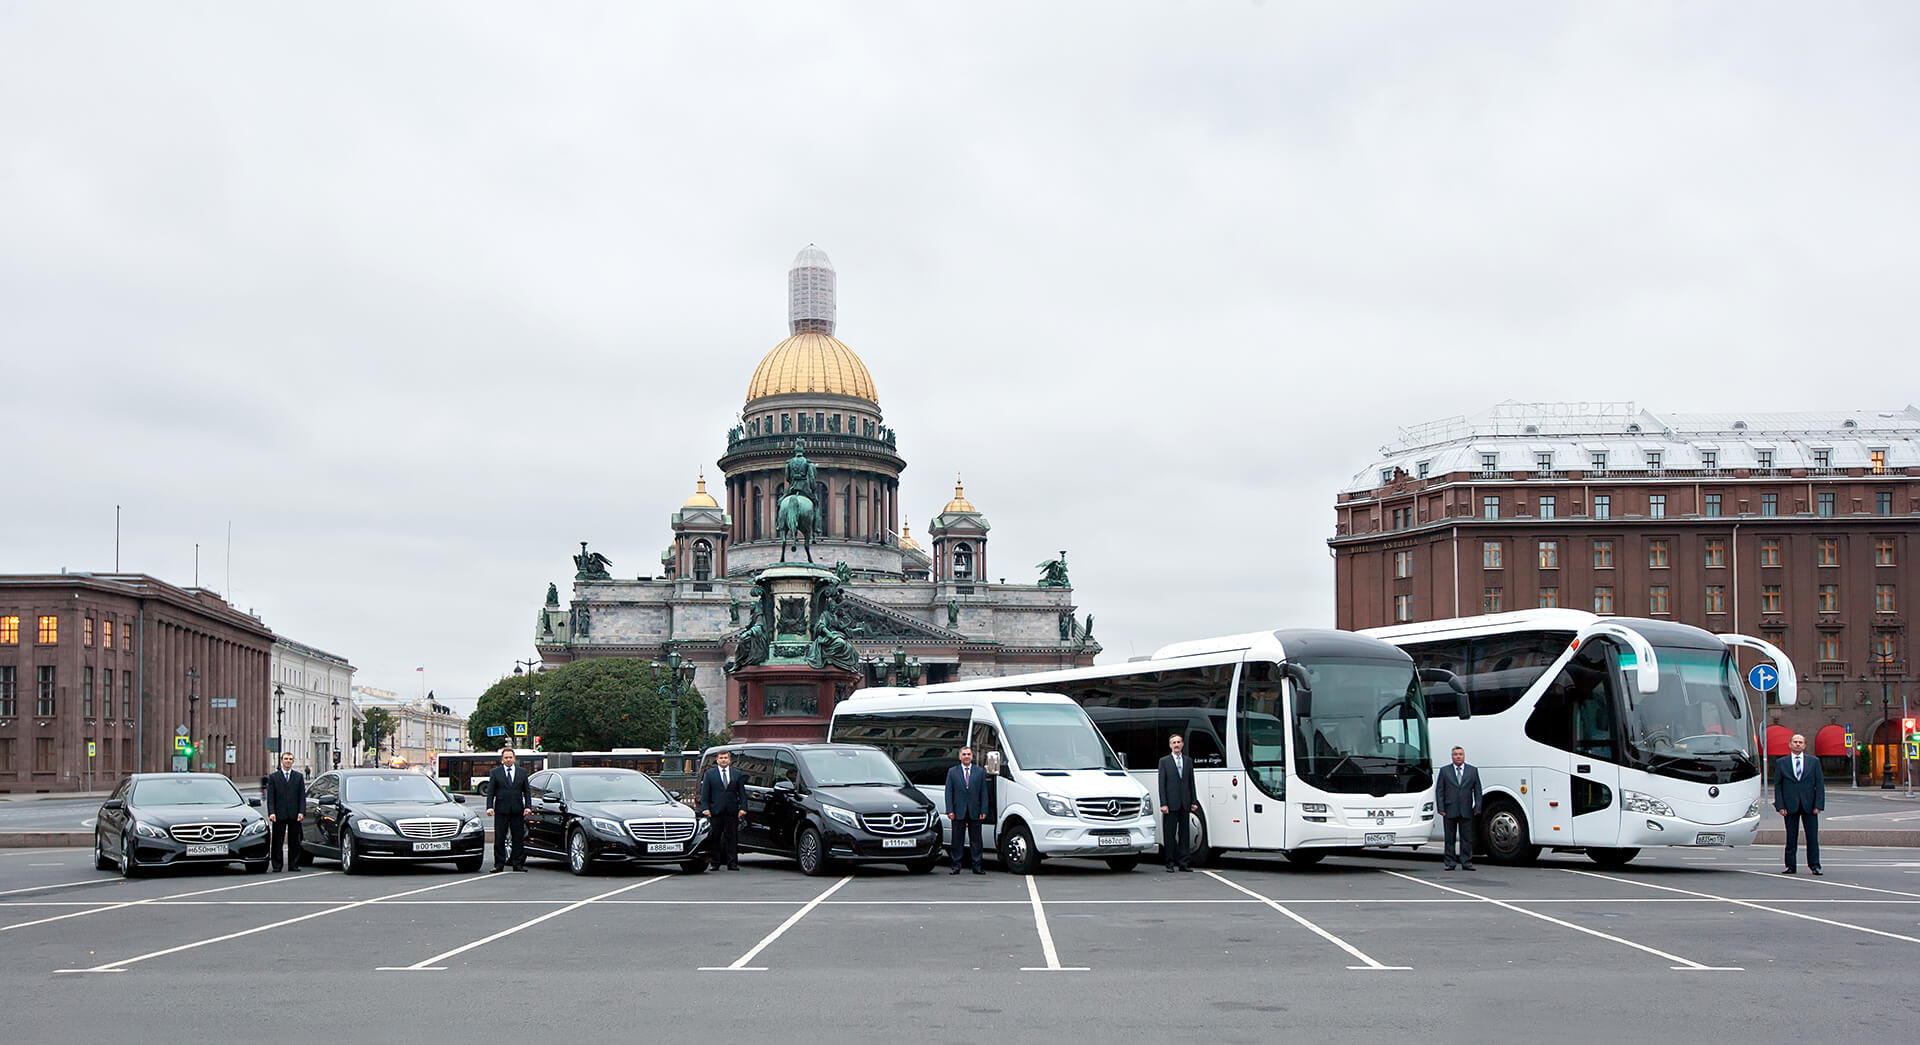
[534,246,1100,736]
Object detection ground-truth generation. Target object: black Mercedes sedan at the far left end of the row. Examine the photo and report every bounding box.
[94,772,267,878]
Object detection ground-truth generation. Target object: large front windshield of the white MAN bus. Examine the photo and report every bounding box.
[1294,661,1432,793]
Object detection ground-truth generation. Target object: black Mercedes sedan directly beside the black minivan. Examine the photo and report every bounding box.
[526,768,707,874]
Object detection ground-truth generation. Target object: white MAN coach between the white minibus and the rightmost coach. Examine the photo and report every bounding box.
[921,628,1446,864]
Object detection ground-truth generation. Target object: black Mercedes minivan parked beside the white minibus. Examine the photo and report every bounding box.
[695,743,941,874]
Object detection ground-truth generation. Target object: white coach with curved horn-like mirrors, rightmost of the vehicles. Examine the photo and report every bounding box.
[1365,609,1795,866]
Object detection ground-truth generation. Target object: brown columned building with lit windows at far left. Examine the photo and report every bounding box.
[0,572,273,791]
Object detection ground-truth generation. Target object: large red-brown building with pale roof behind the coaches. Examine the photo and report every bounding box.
[1329,403,1920,779]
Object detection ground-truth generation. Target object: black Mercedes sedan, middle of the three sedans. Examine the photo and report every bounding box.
[300,768,486,874]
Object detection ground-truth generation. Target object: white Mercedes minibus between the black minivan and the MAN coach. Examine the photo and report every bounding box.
[828,688,1156,874]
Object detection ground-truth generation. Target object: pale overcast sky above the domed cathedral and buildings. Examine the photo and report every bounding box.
[0,2,1920,707]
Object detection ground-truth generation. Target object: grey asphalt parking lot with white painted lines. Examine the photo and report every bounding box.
[0,847,1920,1041]
